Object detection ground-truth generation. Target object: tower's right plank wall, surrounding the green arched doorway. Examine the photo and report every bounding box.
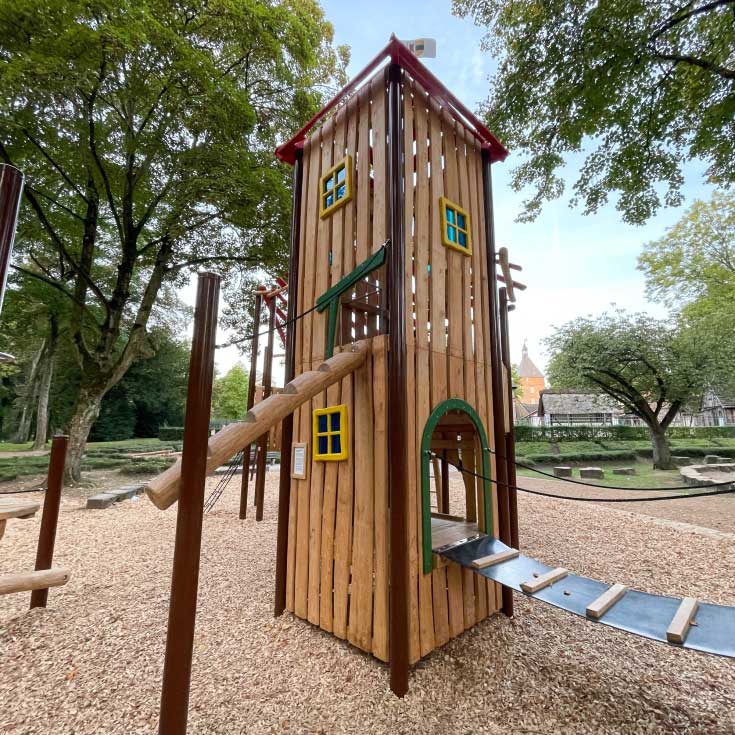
[404,79,498,662]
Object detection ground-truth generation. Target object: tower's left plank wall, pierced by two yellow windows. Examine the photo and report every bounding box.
[286,72,388,661]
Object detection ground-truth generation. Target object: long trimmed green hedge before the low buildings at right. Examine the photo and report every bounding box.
[515,424,735,442]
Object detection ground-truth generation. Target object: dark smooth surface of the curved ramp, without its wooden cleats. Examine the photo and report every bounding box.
[434,536,735,658]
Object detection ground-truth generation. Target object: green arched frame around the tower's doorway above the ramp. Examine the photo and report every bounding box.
[421,398,493,574]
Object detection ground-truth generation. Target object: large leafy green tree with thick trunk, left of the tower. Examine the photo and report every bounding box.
[0,0,347,480]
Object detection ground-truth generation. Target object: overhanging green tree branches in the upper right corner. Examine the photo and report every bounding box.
[453,0,735,223]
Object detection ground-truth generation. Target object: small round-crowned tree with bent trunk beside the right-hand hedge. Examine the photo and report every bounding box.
[545,311,715,469]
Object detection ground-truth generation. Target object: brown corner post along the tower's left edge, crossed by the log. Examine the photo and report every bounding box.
[273,150,303,617]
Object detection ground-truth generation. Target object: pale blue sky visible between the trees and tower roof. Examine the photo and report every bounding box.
[204,0,711,380]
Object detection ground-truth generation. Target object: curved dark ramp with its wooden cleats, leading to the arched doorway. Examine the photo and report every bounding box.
[434,536,735,658]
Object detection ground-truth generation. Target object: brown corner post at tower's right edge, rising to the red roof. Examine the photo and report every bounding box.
[482,150,513,617]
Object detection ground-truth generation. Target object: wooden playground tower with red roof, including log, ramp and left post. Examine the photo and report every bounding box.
[146,33,735,732]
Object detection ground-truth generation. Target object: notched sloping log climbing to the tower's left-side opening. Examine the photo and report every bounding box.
[145,342,368,510]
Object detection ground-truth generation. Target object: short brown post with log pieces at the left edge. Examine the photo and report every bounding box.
[0,436,69,608]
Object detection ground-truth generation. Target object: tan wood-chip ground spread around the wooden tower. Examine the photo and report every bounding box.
[0,473,735,735]
